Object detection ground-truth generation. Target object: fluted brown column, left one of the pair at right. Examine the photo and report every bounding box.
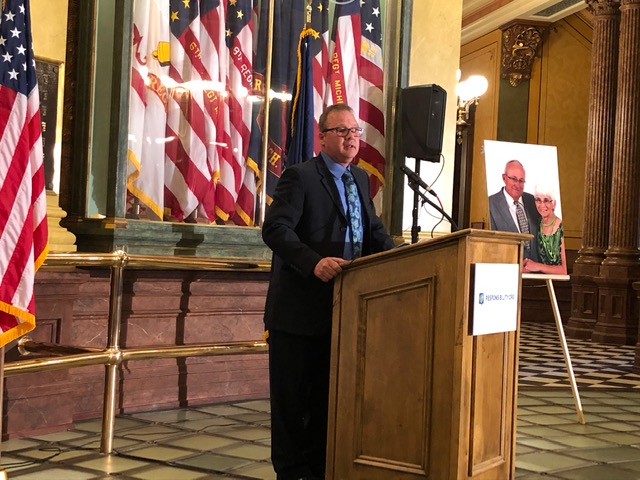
[566,0,620,338]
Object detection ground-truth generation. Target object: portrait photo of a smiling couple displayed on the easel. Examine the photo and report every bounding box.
[484,140,567,275]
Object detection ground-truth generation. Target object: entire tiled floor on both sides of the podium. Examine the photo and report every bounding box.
[0,324,640,480]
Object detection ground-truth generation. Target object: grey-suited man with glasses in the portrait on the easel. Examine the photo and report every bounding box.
[489,160,540,262]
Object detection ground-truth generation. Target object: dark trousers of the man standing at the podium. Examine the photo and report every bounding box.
[269,330,331,480]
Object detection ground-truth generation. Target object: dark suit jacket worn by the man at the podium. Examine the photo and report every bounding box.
[262,157,394,335]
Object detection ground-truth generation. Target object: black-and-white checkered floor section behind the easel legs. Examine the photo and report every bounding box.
[518,323,640,390]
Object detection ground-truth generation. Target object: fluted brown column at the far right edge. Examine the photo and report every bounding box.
[592,0,640,344]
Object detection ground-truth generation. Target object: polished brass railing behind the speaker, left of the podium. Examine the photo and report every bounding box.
[4,250,269,453]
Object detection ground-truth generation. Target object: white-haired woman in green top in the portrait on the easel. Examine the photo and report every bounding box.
[523,185,567,275]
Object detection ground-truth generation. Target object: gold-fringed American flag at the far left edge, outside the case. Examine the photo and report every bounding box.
[0,0,47,346]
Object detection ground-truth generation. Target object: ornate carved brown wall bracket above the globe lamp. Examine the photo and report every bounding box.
[500,20,549,87]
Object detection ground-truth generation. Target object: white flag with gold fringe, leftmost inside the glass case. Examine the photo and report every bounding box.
[127,0,170,220]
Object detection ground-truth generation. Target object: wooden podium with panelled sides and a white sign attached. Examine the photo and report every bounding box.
[326,230,530,480]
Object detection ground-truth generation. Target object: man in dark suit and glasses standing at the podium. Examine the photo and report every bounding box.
[262,104,394,480]
